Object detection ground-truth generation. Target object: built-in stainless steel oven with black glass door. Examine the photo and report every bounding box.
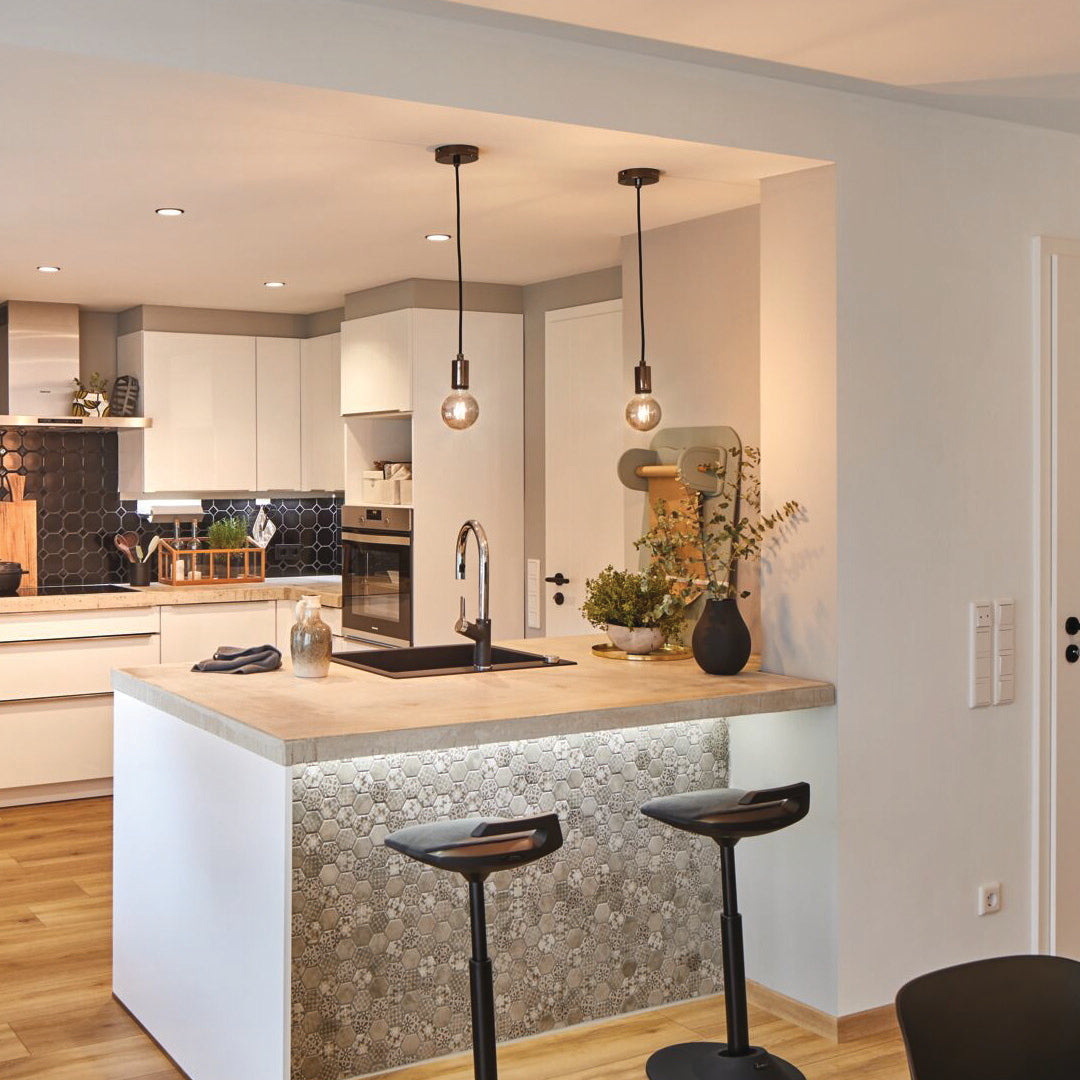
[341,507,413,645]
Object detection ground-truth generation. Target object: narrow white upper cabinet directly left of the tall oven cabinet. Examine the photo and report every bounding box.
[300,334,345,491]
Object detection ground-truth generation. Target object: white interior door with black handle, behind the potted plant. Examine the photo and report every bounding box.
[541,300,625,637]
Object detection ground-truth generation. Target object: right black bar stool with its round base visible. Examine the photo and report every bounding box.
[642,783,810,1080]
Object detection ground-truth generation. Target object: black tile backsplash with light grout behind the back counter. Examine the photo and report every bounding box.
[0,428,341,585]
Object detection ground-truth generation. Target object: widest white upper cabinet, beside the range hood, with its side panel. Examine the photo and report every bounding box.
[117,330,256,492]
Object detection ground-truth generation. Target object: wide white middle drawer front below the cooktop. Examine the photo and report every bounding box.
[0,634,161,701]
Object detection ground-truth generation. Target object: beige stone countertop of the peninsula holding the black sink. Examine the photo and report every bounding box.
[112,635,836,765]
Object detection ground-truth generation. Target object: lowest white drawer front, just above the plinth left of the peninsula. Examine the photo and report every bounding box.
[0,694,112,788]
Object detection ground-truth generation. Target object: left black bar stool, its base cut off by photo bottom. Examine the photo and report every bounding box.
[386,813,563,1080]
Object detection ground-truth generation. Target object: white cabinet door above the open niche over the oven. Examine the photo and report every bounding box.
[341,309,412,416]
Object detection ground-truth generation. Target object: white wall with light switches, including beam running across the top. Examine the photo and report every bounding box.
[14,0,1080,1013]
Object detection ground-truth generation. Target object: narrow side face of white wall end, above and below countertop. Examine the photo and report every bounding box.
[731,166,839,1013]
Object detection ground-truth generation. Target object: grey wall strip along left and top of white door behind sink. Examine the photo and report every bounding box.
[524,267,622,637]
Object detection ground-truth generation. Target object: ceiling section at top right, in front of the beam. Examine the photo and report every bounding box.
[446,0,1080,132]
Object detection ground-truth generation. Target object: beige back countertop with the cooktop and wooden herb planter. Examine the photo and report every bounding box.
[0,577,341,615]
